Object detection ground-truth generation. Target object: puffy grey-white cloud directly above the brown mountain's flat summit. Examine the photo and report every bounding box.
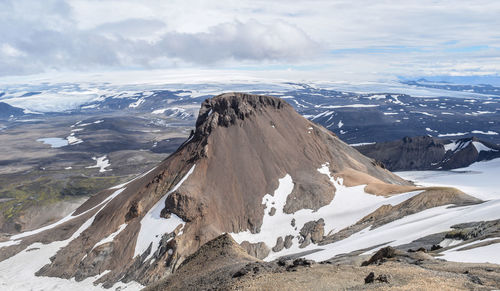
[150,20,318,64]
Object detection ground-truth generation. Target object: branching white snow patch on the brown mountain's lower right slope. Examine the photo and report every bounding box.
[231,164,422,261]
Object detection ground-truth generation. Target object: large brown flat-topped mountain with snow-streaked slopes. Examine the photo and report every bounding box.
[0,93,498,287]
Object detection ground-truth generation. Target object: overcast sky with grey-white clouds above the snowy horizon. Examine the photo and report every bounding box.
[0,0,500,79]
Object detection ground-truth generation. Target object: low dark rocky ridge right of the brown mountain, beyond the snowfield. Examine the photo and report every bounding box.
[356,136,500,171]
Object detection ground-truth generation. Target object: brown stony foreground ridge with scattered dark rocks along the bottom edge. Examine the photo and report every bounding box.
[145,234,500,291]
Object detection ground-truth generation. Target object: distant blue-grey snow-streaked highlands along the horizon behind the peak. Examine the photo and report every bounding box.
[0,80,500,144]
